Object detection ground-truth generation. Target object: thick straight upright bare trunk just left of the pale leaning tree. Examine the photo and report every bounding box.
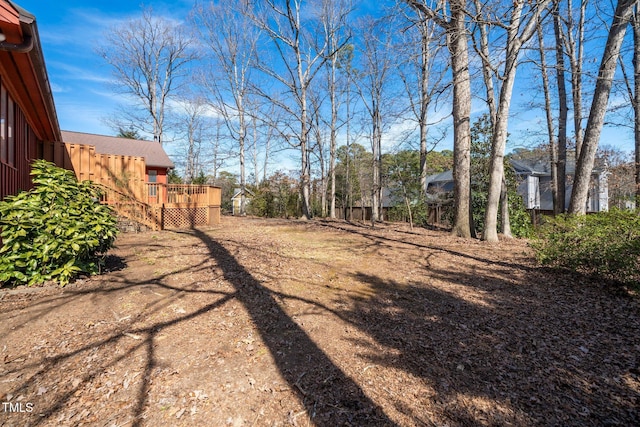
[405,0,471,238]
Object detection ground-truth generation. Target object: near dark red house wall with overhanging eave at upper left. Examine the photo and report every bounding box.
[0,0,64,200]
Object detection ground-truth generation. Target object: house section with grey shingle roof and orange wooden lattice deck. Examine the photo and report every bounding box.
[62,131,222,229]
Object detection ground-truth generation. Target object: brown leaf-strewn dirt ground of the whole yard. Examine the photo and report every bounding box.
[0,217,640,426]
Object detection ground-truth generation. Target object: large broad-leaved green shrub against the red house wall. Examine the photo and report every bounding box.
[0,160,117,286]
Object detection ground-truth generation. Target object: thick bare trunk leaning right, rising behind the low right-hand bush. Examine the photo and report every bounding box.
[569,0,637,214]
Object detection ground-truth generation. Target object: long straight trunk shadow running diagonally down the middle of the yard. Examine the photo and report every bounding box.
[186,229,394,426]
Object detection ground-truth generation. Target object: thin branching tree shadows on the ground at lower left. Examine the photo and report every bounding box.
[3,244,235,426]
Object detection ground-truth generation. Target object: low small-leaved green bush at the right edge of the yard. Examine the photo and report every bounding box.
[533,210,640,284]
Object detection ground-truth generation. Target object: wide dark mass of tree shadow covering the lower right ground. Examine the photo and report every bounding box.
[340,267,640,426]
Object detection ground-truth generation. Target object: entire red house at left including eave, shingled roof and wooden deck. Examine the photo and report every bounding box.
[0,0,221,229]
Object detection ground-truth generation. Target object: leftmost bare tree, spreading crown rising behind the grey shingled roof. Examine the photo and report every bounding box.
[97,9,196,144]
